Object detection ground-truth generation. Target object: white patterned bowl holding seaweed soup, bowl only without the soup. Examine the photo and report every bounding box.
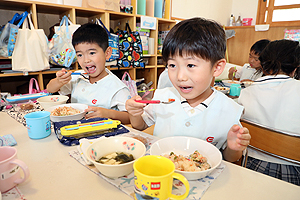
[86,136,146,178]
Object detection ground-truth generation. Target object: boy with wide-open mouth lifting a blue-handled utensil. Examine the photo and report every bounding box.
[47,23,130,124]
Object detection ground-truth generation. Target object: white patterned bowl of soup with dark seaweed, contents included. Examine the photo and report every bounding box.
[86,136,146,178]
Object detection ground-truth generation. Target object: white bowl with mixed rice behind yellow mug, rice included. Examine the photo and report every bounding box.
[150,136,222,180]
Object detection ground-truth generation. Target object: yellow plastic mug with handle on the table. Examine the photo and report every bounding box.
[133,155,190,200]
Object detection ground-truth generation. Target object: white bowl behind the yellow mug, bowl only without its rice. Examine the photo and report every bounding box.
[150,136,222,180]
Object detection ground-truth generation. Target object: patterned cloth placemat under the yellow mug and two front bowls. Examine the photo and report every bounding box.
[69,132,226,200]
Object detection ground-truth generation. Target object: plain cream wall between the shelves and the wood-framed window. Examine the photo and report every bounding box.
[172,0,258,26]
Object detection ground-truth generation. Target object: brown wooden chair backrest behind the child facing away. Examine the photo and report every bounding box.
[241,119,300,164]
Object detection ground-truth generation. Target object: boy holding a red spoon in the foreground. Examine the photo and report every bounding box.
[126,18,250,162]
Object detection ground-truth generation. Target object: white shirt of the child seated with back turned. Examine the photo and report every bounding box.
[238,75,300,164]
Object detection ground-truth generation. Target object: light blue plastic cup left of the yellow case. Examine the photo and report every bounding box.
[24,111,51,139]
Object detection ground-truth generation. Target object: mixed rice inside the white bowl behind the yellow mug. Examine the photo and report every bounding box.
[163,150,211,172]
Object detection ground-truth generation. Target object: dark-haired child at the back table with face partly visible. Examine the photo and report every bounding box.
[228,39,270,82]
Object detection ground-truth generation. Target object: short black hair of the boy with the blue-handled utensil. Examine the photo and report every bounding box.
[72,23,108,52]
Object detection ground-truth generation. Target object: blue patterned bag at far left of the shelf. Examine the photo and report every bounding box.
[0,11,28,57]
